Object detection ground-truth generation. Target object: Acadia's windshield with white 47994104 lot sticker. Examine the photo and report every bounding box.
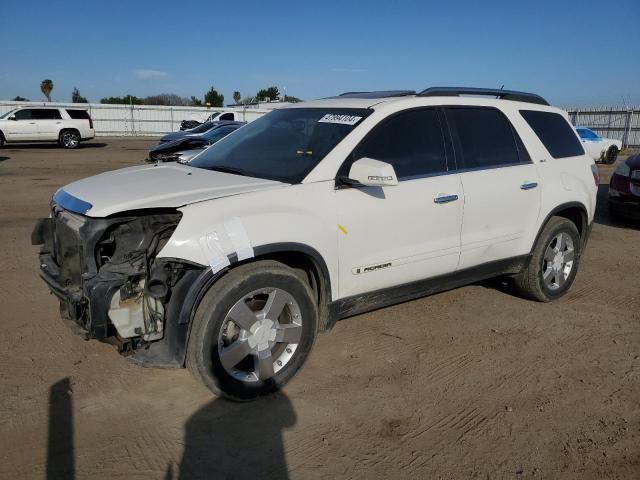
[191,108,372,183]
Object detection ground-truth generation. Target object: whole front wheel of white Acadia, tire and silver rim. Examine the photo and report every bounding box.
[187,260,318,400]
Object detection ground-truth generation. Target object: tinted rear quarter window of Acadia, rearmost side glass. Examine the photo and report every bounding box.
[520,110,584,158]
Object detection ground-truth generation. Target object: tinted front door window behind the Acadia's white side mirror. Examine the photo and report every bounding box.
[348,108,447,180]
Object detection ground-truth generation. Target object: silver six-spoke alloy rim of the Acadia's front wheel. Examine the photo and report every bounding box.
[218,287,302,383]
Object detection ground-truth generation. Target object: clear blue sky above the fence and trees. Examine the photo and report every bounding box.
[0,0,640,106]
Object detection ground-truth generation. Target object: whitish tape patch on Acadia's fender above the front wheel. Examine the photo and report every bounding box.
[198,217,254,273]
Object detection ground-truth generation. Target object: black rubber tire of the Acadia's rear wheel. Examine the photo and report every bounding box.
[515,217,582,302]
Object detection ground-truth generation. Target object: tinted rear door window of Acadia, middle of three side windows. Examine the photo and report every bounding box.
[447,107,531,169]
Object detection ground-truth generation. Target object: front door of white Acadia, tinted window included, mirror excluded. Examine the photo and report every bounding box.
[335,108,463,296]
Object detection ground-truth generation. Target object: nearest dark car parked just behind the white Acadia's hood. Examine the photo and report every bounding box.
[147,123,244,163]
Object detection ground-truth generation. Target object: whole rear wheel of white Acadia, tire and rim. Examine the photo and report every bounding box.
[515,217,581,302]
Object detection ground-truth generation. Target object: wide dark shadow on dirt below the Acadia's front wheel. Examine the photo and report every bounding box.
[174,392,296,480]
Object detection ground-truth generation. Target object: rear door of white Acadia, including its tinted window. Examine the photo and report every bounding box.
[446,106,540,269]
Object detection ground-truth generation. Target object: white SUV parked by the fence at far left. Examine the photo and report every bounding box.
[0,107,95,148]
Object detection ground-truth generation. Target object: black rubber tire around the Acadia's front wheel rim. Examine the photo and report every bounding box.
[186,260,318,401]
